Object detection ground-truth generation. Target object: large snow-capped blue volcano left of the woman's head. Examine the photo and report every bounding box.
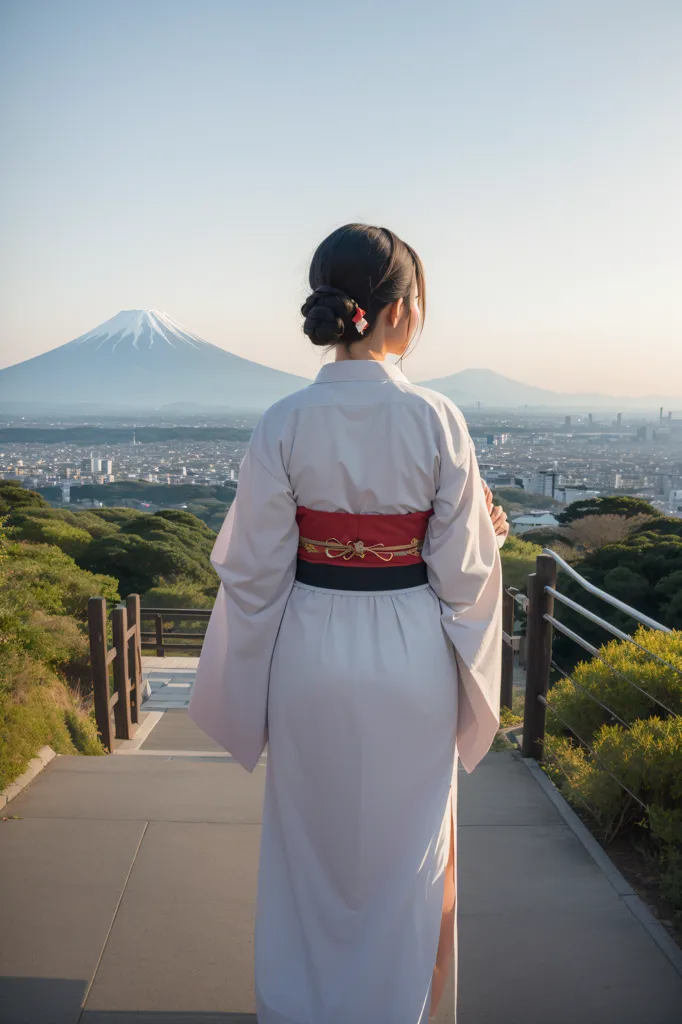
[0,309,309,411]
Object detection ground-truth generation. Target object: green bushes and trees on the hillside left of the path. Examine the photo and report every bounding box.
[0,481,217,788]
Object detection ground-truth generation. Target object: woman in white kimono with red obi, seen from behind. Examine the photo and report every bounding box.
[189,224,506,1024]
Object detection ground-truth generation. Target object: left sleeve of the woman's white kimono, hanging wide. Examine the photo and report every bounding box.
[188,440,298,771]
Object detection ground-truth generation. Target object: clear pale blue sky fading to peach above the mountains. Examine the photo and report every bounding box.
[0,0,682,395]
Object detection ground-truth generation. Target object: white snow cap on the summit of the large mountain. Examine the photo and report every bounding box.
[71,309,210,351]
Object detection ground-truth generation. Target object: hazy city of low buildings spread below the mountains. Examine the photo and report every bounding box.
[0,409,682,532]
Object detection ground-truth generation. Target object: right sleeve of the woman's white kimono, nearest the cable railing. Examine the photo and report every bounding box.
[423,413,502,772]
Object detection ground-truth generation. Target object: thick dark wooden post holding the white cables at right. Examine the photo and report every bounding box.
[521,555,556,761]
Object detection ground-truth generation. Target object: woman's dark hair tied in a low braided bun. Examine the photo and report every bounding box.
[301,224,426,349]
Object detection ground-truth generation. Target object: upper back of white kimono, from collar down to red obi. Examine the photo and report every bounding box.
[252,359,469,514]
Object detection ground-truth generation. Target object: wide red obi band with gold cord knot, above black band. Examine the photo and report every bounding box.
[296,505,433,566]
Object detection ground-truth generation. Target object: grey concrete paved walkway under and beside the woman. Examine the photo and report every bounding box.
[0,710,682,1024]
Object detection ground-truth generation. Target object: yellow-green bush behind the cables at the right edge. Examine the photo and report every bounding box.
[545,628,682,913]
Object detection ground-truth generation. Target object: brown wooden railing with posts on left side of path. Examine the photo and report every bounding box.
[88,594,211,753]
